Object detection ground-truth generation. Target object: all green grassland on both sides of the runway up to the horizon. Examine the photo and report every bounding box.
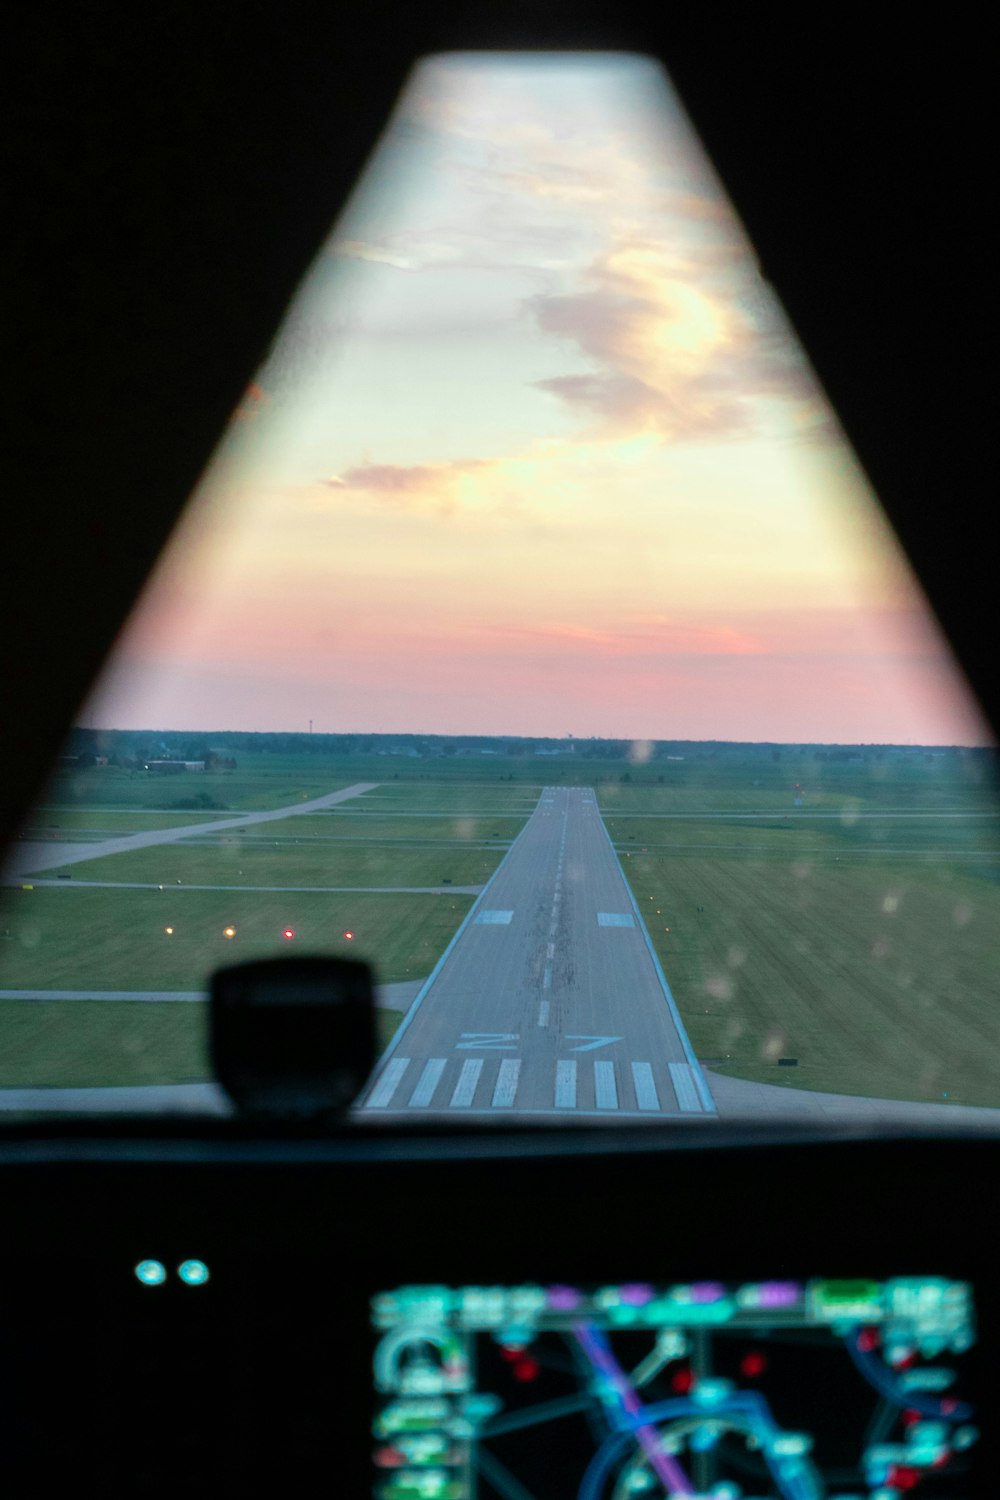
[0,749,1000,1106]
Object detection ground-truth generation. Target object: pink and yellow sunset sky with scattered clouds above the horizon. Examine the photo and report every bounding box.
[88,54,990,744]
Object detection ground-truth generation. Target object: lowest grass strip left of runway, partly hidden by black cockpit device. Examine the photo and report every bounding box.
[0,1001,403,1089]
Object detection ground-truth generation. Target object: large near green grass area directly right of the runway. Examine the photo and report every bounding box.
[622,848,1000,1106]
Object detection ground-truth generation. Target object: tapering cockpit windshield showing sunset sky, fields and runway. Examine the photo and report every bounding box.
[0,54,1000,1122]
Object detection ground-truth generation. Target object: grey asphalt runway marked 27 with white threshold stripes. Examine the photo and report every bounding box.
[361,788,715,1119]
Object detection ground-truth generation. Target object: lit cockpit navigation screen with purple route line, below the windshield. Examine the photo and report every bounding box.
[372,1277,978,1500]
